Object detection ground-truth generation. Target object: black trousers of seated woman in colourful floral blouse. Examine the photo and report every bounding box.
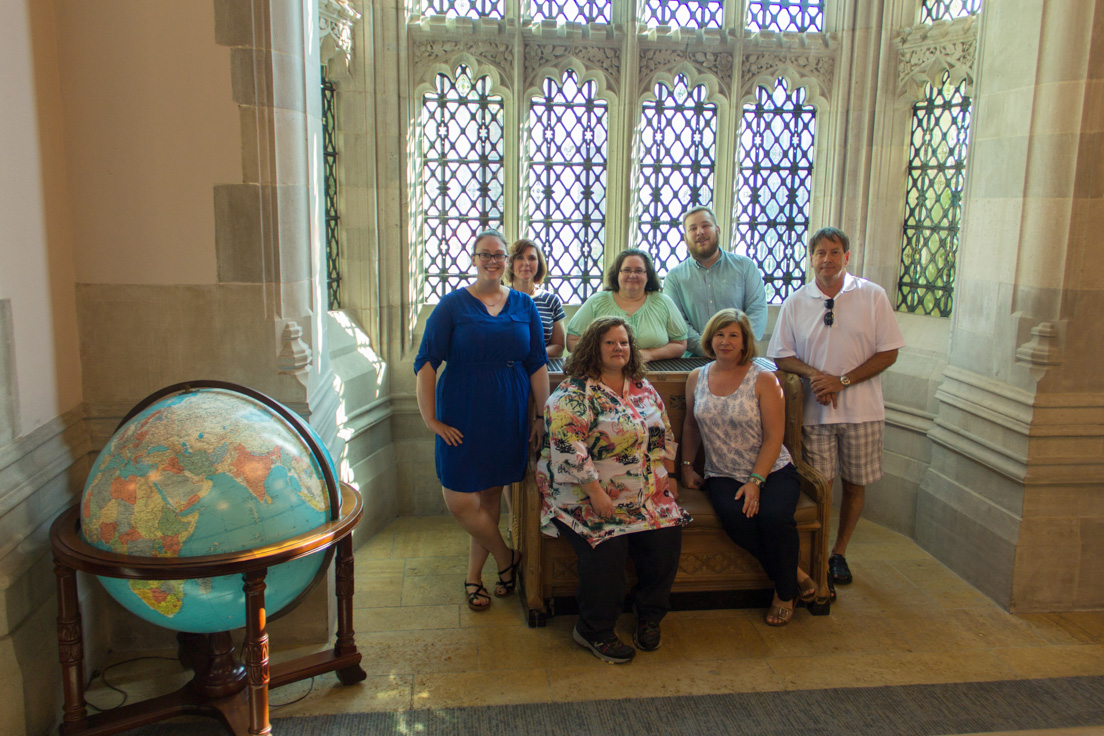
[555,521,682,641]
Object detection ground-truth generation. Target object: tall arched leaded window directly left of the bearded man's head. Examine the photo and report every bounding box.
[633,74,716,275]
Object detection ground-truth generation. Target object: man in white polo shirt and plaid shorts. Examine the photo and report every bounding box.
[766,227,904,585]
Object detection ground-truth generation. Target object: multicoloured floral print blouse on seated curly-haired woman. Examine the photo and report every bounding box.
[537,378,690,546]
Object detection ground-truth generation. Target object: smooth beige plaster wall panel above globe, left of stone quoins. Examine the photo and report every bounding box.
[56,0,242,284]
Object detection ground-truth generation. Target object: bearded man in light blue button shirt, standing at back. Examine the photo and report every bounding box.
[664,206,766,355]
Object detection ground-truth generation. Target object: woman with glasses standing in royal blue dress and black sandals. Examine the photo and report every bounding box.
[414,231,549,611]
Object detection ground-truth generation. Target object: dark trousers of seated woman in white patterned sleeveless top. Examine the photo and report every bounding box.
[702,463,802,600]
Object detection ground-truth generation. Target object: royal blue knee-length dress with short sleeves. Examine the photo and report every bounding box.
[414,288,548,493]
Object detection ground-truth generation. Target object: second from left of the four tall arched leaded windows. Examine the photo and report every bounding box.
[527,70,608,303]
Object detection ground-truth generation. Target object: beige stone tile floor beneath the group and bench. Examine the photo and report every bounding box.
[88,516,1104,733]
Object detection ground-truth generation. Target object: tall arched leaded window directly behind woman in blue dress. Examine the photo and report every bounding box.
[420,65,503,303]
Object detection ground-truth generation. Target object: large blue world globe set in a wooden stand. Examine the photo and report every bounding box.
[81,382,337,633]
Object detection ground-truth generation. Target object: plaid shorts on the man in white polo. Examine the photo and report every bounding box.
[802,422,885,486]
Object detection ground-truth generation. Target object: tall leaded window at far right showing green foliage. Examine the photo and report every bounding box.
[898,73,970,317]
